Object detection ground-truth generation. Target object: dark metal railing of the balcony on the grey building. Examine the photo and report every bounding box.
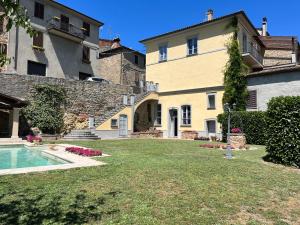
[48,18,85,39]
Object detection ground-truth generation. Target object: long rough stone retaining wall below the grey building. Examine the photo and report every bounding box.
[0,73,132,117]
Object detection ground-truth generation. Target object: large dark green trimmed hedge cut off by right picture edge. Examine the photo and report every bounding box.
[266,96,300,167]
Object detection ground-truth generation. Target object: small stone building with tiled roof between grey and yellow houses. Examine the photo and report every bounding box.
[98,38,145,87]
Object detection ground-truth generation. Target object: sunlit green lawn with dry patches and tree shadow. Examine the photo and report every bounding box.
[0,140,300,225]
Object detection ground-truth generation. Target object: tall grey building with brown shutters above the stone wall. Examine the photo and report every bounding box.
[1,0,103,80]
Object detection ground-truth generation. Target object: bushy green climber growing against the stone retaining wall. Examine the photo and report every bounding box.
[22,84,66,134]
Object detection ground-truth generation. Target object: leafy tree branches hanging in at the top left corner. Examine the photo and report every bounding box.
[0,0,35,67]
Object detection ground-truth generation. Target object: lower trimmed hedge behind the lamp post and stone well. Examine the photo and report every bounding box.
[218,111,267,145]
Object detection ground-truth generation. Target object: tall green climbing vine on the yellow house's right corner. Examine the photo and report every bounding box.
[223,17,248,111]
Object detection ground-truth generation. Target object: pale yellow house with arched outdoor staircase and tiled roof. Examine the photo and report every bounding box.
[97,10,263,138]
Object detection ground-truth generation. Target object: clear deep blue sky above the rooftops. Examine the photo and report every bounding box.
[57,0,300,53]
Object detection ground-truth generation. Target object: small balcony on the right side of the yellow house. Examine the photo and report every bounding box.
[242,43,263,69]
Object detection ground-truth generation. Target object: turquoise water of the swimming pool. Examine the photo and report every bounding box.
[0,145,67,169]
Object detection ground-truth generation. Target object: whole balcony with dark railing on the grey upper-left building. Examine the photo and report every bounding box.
[47,18,85,43]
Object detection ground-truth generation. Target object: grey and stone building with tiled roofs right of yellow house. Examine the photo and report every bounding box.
[247,18,300,111]
